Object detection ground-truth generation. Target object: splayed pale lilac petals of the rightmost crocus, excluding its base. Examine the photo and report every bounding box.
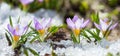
[94,19,118,34]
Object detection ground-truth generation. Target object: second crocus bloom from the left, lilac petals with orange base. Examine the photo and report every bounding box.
[34,18,52,35]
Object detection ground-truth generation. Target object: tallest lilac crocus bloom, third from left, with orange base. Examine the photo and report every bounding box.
[66,15,89,37]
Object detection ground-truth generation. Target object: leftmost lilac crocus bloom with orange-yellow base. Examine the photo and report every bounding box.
[7,24,28,42]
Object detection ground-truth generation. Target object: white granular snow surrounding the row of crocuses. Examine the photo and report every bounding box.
[0,3,120,56]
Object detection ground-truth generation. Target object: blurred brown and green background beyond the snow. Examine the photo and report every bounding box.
[0,0,120,40]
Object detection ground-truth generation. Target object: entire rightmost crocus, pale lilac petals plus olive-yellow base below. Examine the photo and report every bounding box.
[94,18,118,39]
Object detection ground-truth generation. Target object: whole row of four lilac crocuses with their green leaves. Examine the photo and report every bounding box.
[6,15,118,55]
